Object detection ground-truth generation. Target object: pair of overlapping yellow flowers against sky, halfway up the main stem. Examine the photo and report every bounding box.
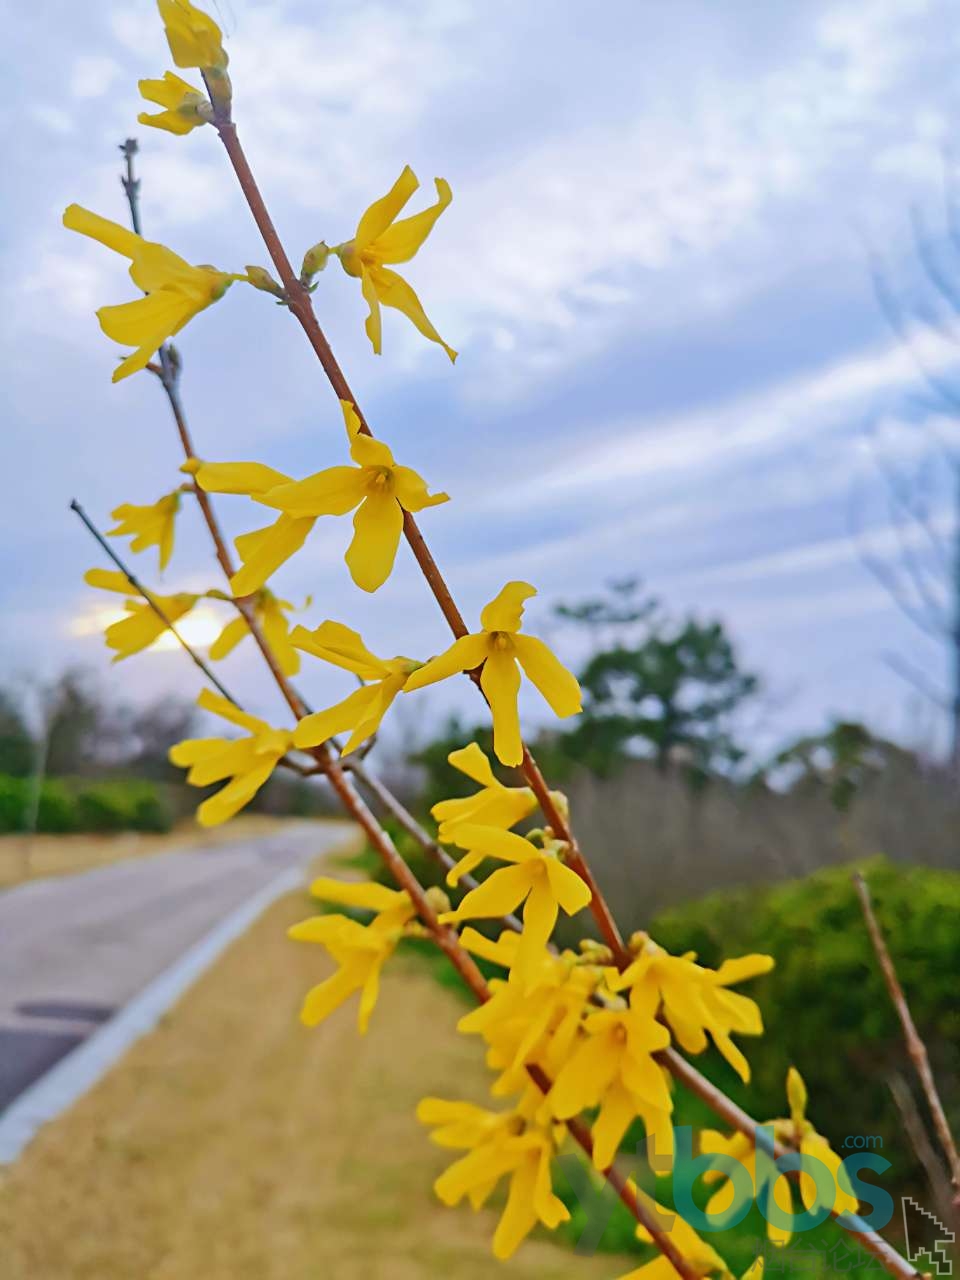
[197,401,449,595]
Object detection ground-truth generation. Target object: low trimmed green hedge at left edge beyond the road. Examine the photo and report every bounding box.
[0,774,173,835]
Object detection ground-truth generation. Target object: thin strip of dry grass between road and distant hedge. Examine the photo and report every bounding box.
[0,814,296,888]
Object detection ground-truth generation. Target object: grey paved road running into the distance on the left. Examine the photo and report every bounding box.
[0,823,344,1112]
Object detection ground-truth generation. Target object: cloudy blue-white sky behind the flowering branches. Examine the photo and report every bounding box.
[0,0,960,744]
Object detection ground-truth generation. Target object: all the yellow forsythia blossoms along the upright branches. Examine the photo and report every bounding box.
[73,0,855,1280]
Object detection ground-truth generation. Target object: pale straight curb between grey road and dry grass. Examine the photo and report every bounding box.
[0,868,305,1165]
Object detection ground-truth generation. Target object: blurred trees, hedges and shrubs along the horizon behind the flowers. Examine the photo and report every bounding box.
[0,580,960,1254]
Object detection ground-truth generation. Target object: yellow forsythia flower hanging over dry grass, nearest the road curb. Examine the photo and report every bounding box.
[288,877,416,1036]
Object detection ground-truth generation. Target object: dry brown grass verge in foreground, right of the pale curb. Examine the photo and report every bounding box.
[0,895,630,1280]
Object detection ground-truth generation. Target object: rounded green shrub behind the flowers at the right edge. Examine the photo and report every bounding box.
[652,859,960,1194]
